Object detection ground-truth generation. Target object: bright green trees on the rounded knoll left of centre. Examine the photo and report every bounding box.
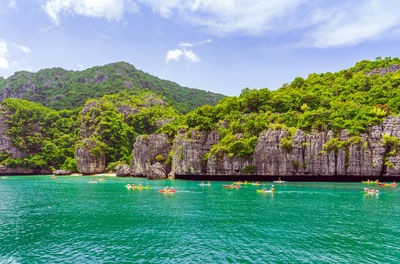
[79,93,179,168]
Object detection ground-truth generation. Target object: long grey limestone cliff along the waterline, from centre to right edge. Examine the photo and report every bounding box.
[133,117,400,178]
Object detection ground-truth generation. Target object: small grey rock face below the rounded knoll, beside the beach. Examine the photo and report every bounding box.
[75,139,106,175]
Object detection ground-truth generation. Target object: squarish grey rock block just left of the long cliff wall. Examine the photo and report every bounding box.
[132,134,170,179]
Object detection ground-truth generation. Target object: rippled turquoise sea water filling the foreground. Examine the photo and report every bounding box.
[0,176,400,263]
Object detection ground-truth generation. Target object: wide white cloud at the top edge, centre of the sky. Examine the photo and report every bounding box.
[138,0,306,35]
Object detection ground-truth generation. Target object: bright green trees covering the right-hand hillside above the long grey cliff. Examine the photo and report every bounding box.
[161,58,400,159]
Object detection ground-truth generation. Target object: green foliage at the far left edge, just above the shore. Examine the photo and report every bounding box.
[2,98,80,171]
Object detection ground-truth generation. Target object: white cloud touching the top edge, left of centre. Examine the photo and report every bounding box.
[42,0,139,25]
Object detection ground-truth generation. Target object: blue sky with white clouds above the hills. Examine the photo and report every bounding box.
[0,0,400,96]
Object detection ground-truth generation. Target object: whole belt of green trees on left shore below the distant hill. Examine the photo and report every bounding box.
[0,92,178,171]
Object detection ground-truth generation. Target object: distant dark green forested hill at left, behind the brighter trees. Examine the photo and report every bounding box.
[0,62,224,113]
